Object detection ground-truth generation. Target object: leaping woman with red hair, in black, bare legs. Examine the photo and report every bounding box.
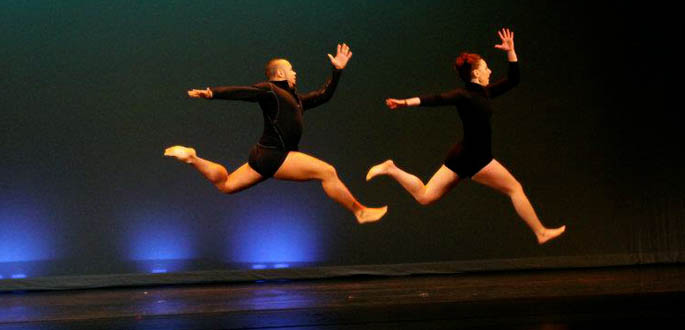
[366,29,566,244]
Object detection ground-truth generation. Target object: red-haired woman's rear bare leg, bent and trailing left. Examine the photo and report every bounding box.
[366,160,459,205]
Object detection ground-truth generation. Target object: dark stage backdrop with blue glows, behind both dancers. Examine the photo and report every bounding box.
[0,0,685,287]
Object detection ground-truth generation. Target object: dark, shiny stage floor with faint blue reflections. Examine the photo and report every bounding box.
[0,265,685,330]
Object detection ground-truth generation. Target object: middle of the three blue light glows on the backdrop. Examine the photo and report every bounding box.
[123,211,196,260]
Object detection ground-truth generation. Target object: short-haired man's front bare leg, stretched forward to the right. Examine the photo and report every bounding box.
[274,151,388,223]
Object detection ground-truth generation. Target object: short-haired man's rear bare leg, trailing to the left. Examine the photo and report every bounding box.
[164,146,264,194]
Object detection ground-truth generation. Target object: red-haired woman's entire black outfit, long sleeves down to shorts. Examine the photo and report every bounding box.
[420,62,520,178]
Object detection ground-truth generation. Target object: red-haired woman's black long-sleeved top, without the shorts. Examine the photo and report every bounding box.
[420,62,520,155]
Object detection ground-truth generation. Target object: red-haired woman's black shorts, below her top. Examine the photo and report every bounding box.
[445,142,493,179]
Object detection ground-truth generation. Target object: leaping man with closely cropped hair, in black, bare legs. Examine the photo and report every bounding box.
[164,44,387,223]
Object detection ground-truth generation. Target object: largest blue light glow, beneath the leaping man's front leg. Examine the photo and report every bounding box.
[227,208,319,268]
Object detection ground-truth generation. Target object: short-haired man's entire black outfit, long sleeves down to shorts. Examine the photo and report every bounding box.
[210,69,342,177]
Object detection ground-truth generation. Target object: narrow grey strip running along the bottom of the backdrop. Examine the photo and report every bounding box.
[0,251,685,292]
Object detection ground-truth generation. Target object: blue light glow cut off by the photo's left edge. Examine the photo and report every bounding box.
[0,196,57,263]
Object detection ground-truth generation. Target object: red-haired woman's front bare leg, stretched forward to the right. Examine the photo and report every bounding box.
[472,159,566,244]
